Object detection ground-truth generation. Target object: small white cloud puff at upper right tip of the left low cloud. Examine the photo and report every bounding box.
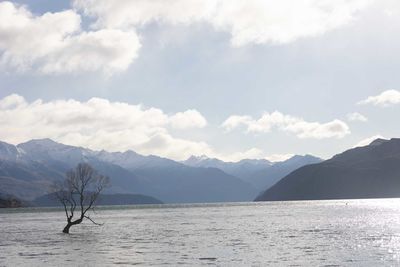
[170,109,207,129]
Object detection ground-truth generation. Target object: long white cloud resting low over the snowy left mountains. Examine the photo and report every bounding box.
[0,94,214,159]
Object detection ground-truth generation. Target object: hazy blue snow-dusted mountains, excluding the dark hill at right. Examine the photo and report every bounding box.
[0,139,320,203]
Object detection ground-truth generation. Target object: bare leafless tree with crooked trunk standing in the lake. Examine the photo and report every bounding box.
[54,163,109,234]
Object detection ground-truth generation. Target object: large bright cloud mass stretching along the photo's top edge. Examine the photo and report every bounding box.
[0,0,370,76]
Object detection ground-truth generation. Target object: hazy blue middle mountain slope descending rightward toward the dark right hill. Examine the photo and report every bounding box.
[98,151,258,203]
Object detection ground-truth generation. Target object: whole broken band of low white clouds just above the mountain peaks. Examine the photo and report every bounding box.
[0,94,349,161]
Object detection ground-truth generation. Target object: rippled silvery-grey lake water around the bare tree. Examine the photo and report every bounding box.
[0,199,400,266]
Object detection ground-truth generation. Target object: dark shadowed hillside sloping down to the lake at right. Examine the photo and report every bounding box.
[256,139,400,201]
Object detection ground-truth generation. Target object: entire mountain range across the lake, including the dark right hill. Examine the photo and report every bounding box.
[0,138,400,204]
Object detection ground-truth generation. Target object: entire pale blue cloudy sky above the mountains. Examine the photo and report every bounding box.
[0,0,400,161]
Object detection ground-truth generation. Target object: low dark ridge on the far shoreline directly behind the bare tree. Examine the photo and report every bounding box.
[32,194,163,207]
